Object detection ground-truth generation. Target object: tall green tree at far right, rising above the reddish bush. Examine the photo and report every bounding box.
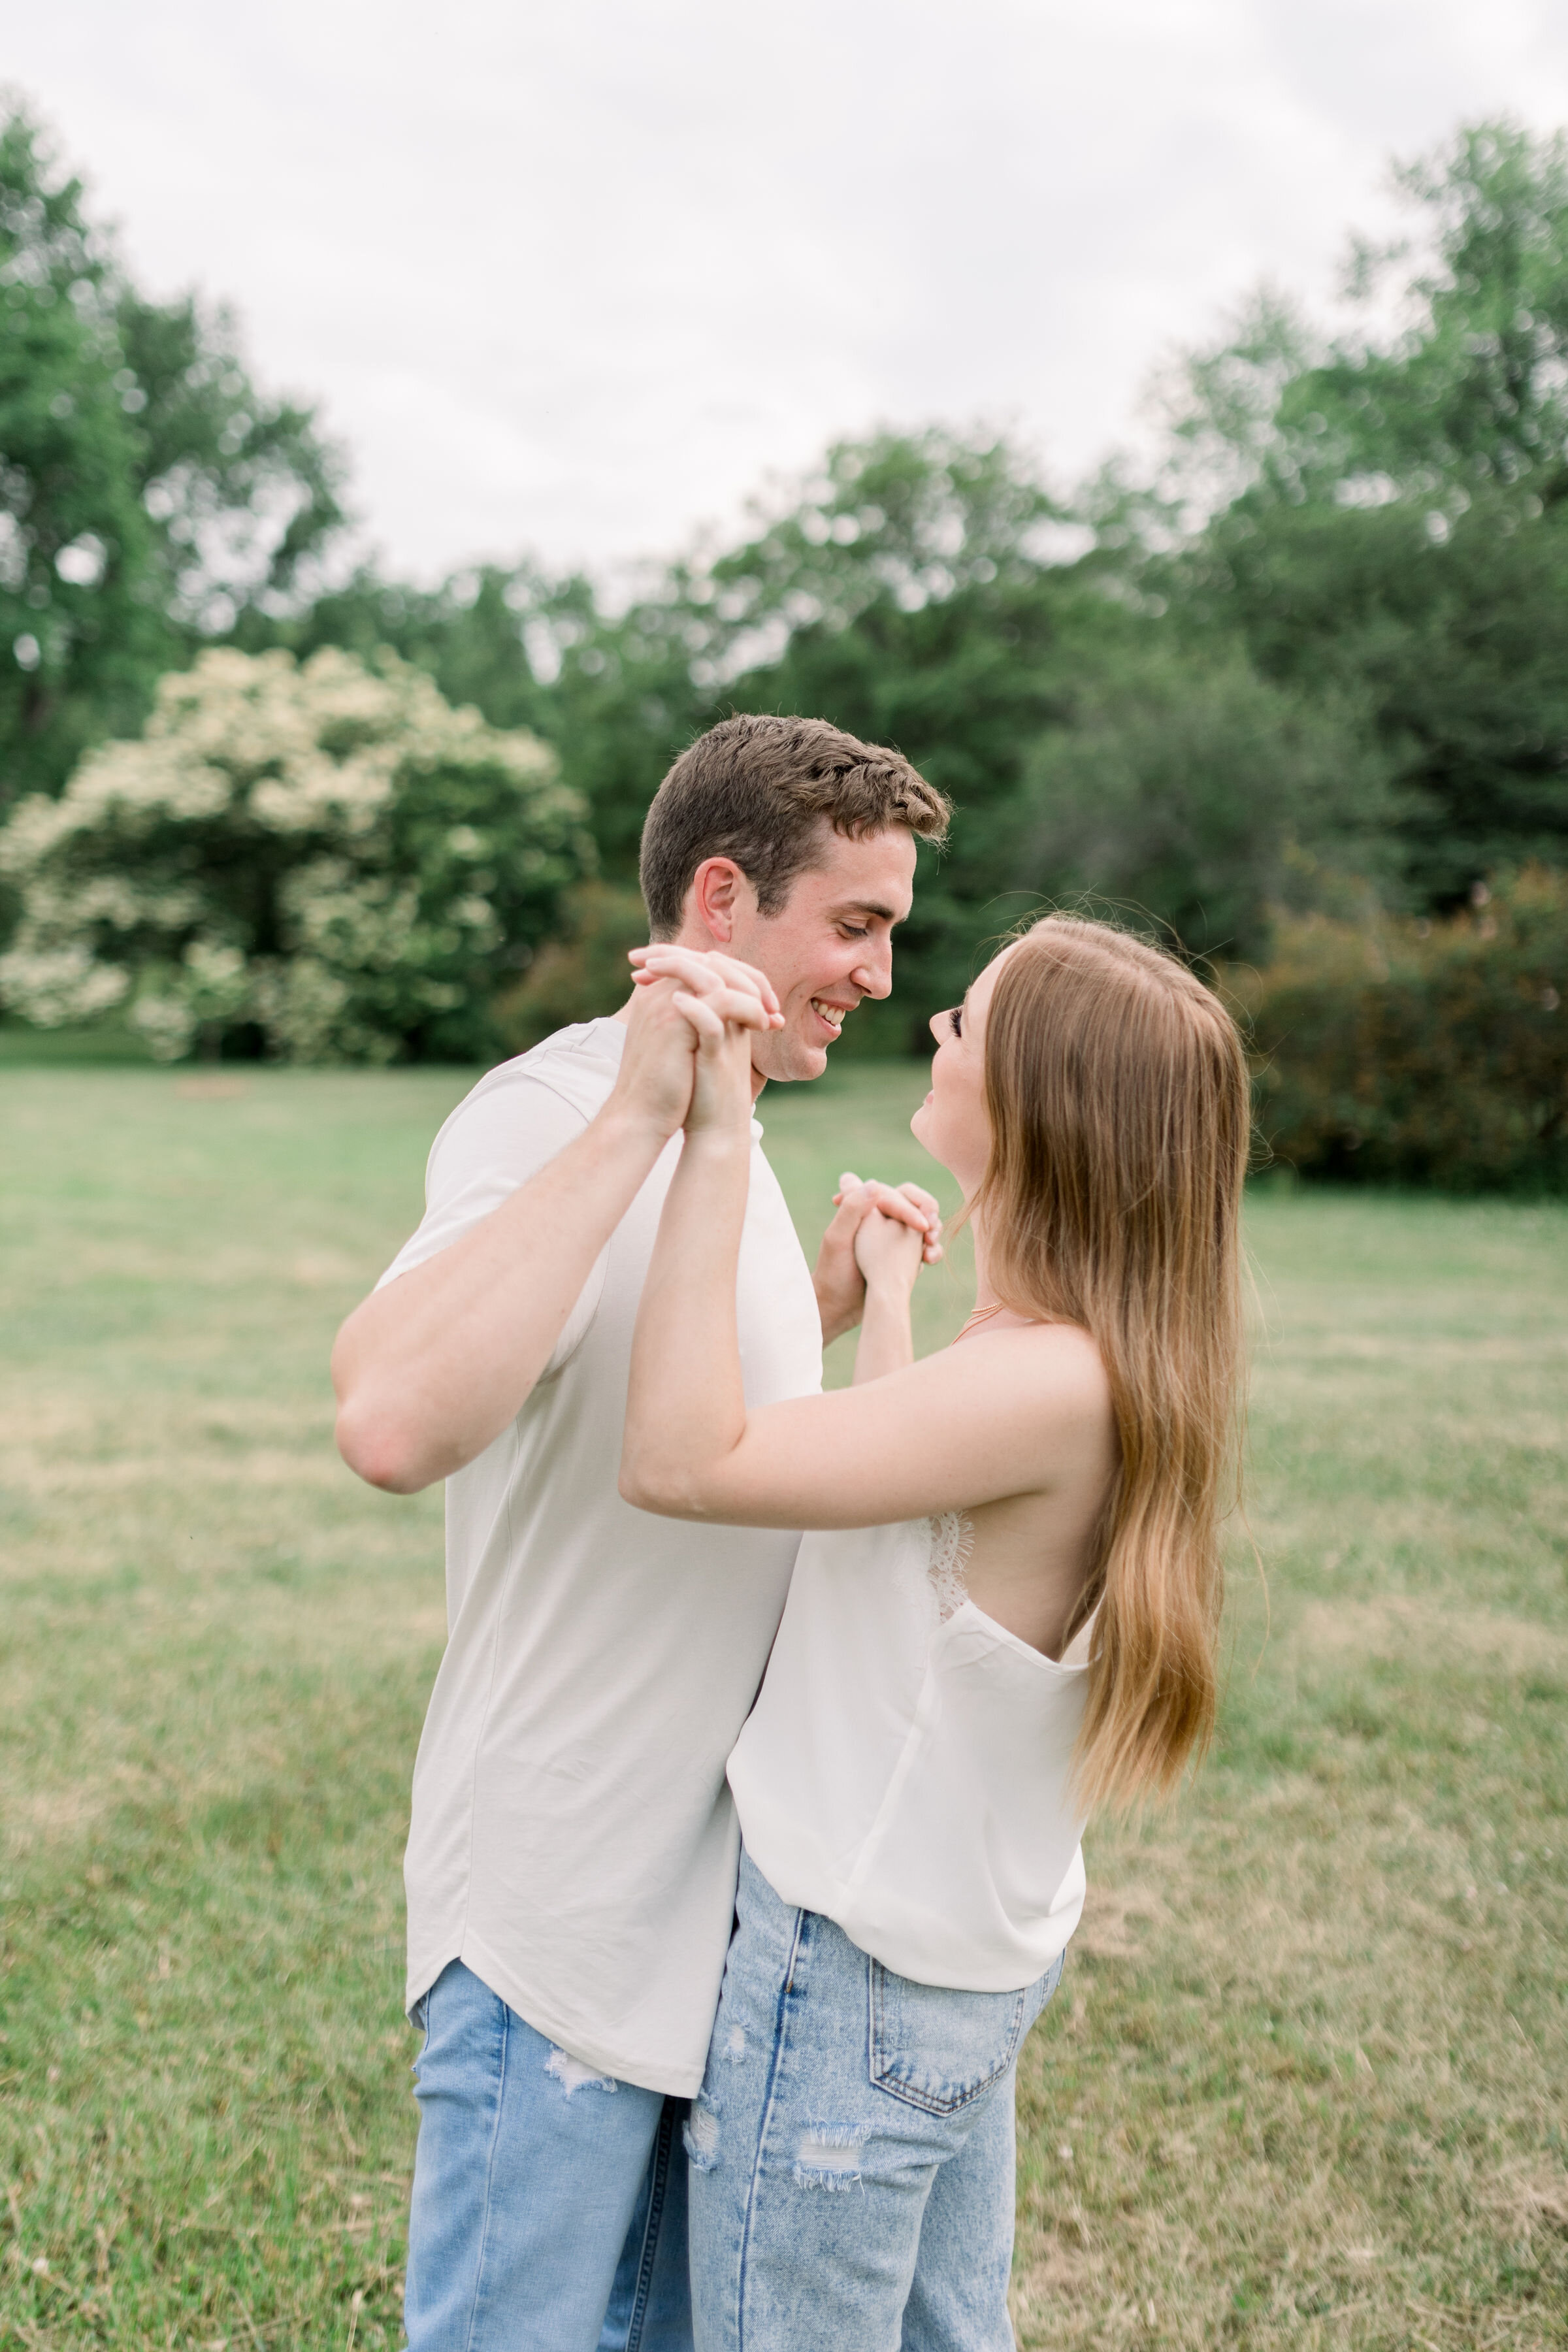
[1114,122,1568,910]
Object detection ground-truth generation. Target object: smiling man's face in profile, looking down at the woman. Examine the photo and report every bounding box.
[728,821,915,1079]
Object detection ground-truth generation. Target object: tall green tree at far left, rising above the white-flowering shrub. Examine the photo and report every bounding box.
[0,106,341,809]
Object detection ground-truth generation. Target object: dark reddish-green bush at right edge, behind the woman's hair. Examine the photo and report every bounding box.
[1225,866,1568,1192]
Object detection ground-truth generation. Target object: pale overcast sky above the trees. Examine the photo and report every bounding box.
[12,0,1568,576]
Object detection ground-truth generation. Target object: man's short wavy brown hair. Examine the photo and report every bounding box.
[642,715,950,938]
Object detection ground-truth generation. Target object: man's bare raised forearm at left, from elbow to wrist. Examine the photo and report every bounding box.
[331,1103,665,1494]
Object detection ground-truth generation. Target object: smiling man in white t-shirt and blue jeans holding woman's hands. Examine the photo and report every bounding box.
[334,717,947,2352]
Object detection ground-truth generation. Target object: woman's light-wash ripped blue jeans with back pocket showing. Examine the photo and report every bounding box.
[687,1854,1062,2352]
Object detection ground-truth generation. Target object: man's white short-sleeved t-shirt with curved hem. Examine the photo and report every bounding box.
[381,1021,823,2093]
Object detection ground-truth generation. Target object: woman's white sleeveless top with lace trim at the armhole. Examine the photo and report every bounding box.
[728,1514,1091,1992]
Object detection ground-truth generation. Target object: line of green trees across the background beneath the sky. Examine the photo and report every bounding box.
[0,115,1568,1176]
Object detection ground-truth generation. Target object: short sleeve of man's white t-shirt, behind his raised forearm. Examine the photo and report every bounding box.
[376,1070,609,1379]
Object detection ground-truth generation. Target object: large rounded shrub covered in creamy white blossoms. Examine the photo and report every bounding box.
[0,651,593,1061]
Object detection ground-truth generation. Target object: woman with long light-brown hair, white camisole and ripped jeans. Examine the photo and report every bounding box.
[621,915,1249,2352]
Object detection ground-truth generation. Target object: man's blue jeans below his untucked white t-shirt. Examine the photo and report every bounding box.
[404,1959,691,2352]
